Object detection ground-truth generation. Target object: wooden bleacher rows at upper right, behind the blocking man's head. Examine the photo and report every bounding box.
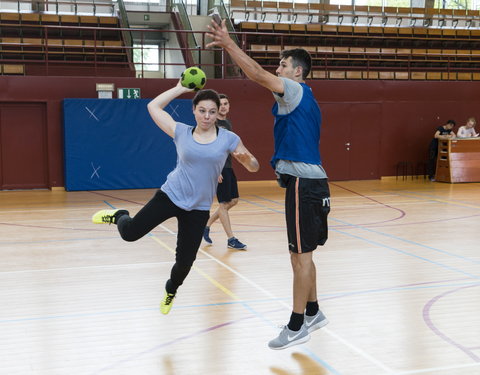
[225,0,480,80]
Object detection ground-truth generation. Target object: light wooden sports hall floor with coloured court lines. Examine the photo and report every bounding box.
[0,179,480,375]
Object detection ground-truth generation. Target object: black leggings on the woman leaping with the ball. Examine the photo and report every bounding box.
[117,190,210,293]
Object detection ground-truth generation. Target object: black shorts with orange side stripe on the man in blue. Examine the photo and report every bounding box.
[279,174,330,253]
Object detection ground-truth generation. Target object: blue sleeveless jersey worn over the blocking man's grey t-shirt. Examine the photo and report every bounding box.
[270,83,322,168]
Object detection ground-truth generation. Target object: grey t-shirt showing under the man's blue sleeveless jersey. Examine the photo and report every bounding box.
[273,77,327,178]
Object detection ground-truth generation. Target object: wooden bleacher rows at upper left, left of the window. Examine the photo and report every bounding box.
[0,13,134,75]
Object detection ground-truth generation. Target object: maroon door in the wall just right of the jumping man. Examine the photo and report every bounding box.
[320,103,381,181]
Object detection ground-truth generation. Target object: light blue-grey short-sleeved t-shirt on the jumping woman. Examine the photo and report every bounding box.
[160,122,240,211]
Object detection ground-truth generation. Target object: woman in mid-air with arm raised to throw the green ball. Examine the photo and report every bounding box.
[92,81,259,314]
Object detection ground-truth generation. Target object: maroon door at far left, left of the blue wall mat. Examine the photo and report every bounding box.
[0,103,48,189]
